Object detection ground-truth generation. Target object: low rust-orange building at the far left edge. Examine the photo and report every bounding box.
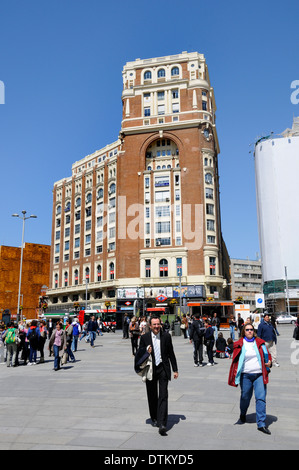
[0,243,51,319]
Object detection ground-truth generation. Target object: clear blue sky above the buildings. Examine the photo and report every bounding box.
[0,0,299,259]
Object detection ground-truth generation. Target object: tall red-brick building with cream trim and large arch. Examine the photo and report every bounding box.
[48,52,229,320]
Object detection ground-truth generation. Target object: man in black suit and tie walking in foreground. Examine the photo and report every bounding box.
[139,317,179,436]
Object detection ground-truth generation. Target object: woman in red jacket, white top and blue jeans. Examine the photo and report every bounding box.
[228,324,272,434]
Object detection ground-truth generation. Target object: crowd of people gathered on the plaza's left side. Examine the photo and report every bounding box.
[0,317,103,371]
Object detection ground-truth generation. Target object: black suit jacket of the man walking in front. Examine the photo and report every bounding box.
[139,328,178,380]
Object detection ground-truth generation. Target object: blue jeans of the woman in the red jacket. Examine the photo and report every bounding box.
[240,373,267,428]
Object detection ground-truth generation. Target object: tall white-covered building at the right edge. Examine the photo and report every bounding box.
[255,118,299,311]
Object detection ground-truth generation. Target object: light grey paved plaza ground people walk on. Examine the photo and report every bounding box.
[0,325,299,452]
